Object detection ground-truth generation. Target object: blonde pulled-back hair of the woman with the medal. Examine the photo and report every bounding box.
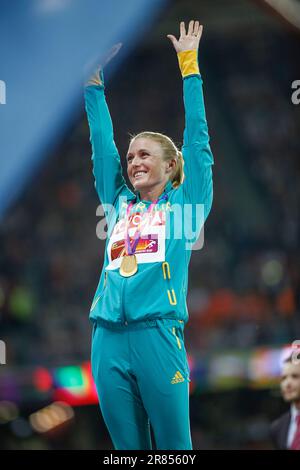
[131,131,184,188]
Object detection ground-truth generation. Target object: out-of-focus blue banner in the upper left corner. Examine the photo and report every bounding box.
[0,0,166,218]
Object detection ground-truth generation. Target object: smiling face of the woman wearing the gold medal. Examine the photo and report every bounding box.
[127,137,174,198]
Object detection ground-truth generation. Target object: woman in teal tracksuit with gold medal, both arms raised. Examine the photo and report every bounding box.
[85,21,213,450]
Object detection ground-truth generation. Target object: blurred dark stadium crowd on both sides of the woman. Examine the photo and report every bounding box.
[0,32,300,365]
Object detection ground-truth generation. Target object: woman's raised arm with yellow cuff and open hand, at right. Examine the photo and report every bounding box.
[168,21,213,219]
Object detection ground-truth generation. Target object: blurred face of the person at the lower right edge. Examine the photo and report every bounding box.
[280,362,300,408]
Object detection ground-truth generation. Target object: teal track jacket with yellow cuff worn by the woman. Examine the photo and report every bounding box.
[85,50,213,325]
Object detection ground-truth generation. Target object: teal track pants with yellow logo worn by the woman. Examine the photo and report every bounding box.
[92,319,192,450]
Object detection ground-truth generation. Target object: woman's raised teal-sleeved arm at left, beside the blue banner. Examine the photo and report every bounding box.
[84,46,131,216]
